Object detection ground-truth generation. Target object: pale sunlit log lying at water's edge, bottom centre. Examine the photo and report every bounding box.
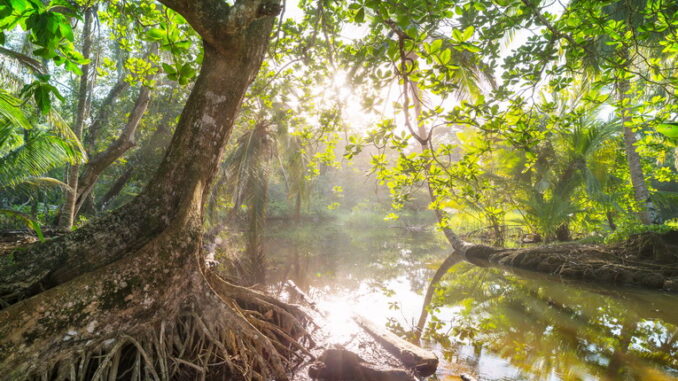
[353,315,438,377]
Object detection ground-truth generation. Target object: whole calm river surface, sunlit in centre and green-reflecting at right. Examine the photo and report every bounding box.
[265,223,678,381]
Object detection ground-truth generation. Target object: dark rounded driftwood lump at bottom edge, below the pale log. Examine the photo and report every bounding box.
[308,346,415,381]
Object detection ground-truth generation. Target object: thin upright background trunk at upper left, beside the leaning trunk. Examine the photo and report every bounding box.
[59,8,94,229]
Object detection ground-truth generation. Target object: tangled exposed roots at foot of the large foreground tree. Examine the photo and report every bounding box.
[3,277,311,381]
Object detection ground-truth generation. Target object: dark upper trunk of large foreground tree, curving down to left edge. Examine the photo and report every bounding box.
[0,2,282,303]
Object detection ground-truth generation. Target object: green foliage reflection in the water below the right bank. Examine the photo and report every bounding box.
[427,263,678,380]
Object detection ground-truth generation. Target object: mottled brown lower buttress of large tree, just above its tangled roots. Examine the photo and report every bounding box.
[0,216,199,379]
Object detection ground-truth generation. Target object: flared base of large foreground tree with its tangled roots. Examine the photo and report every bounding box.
[0,215,313,381]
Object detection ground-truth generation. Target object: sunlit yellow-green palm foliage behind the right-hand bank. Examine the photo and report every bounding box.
[505,116,619,241]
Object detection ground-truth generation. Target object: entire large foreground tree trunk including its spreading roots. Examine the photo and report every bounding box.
[0,0,310,380]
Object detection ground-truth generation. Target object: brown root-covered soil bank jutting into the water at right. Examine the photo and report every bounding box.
[466,231,678,292]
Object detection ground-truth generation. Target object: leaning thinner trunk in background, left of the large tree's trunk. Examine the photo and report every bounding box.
[74,86,151,216]
